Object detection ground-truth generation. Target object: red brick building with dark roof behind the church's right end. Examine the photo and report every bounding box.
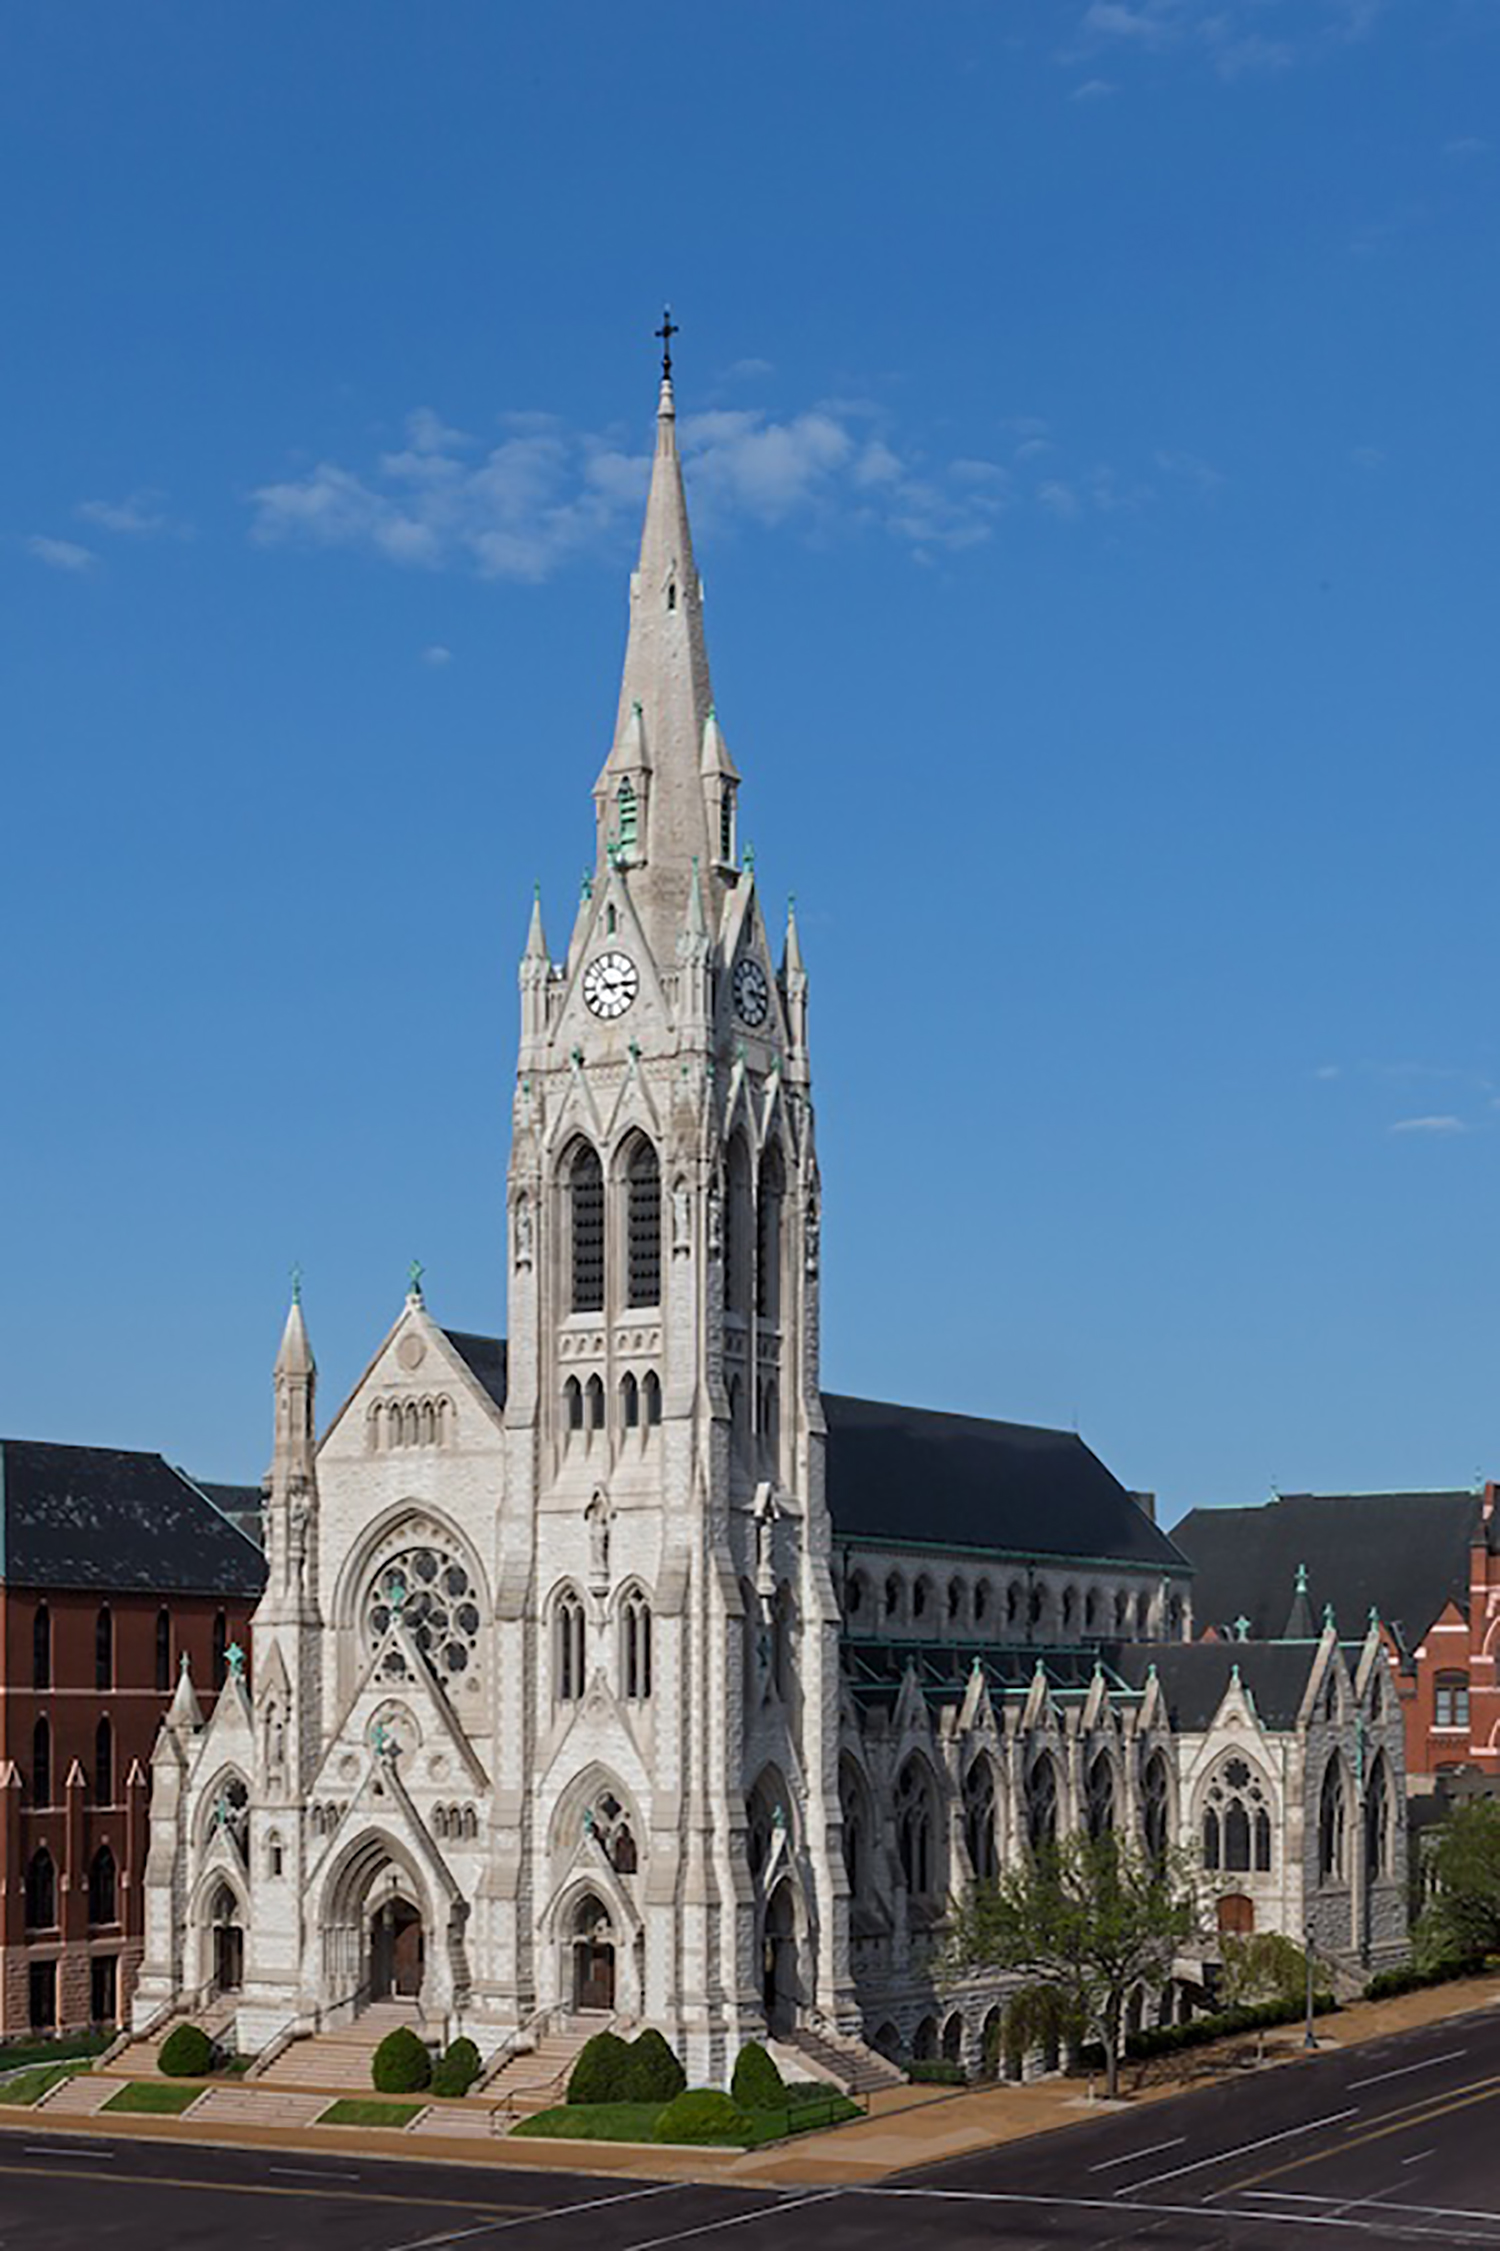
[1171,1483,1500,1794]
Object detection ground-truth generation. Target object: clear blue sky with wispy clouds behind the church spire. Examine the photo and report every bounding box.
[0,0,1500,1519]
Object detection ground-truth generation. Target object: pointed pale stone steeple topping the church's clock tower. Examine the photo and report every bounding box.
[595,346,739,961]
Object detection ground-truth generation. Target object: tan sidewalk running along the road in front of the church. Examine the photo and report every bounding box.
[11,1974,1500,2188]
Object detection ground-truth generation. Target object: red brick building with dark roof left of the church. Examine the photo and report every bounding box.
[0,1438,264,2039]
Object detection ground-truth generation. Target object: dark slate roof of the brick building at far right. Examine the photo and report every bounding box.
[1171,1492,1482,1648]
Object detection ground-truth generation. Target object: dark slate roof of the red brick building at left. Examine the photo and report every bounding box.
[0,1438,266,1596]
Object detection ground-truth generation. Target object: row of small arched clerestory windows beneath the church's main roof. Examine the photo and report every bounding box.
[842,1562,1187,1641]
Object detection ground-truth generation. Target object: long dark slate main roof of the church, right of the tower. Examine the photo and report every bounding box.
[822,1393,1187,1571]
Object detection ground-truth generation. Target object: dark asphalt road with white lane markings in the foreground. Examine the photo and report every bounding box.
[0,2012,1500,2251]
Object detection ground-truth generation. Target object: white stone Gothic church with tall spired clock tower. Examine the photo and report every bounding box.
[133,358,1405,2082]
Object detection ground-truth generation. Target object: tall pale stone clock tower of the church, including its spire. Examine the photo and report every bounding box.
[500,362,856,2080]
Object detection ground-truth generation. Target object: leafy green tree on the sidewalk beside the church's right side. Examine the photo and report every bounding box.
[946,1837,1203,2096]
